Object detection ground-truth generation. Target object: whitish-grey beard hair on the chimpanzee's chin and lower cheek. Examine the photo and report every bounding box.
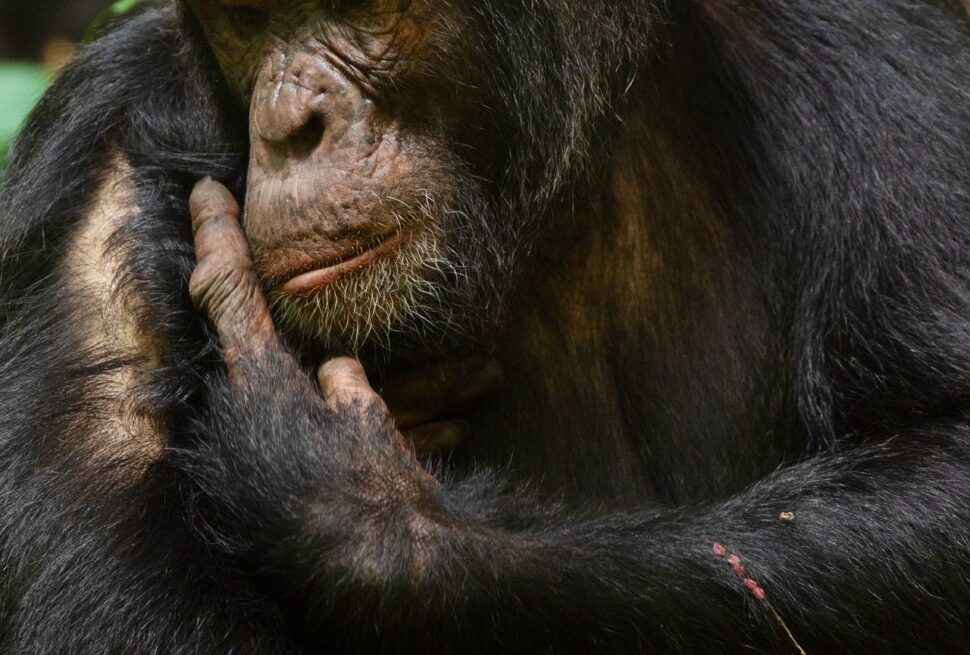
[271,193,503,355]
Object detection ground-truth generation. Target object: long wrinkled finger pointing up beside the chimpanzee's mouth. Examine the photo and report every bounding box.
[189,178,275,353]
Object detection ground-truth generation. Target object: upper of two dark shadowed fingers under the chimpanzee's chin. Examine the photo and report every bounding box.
[381,358,504,430]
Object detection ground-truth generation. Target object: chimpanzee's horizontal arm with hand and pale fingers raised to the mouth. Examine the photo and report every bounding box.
[180,179,970,653]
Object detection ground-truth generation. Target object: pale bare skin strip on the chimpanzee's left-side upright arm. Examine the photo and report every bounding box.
[64,155,165,474]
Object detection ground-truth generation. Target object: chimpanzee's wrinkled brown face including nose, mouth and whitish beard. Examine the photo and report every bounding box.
[182,0,496,350]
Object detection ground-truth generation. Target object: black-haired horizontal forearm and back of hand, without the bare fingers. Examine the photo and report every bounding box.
[180,376,970,652]
